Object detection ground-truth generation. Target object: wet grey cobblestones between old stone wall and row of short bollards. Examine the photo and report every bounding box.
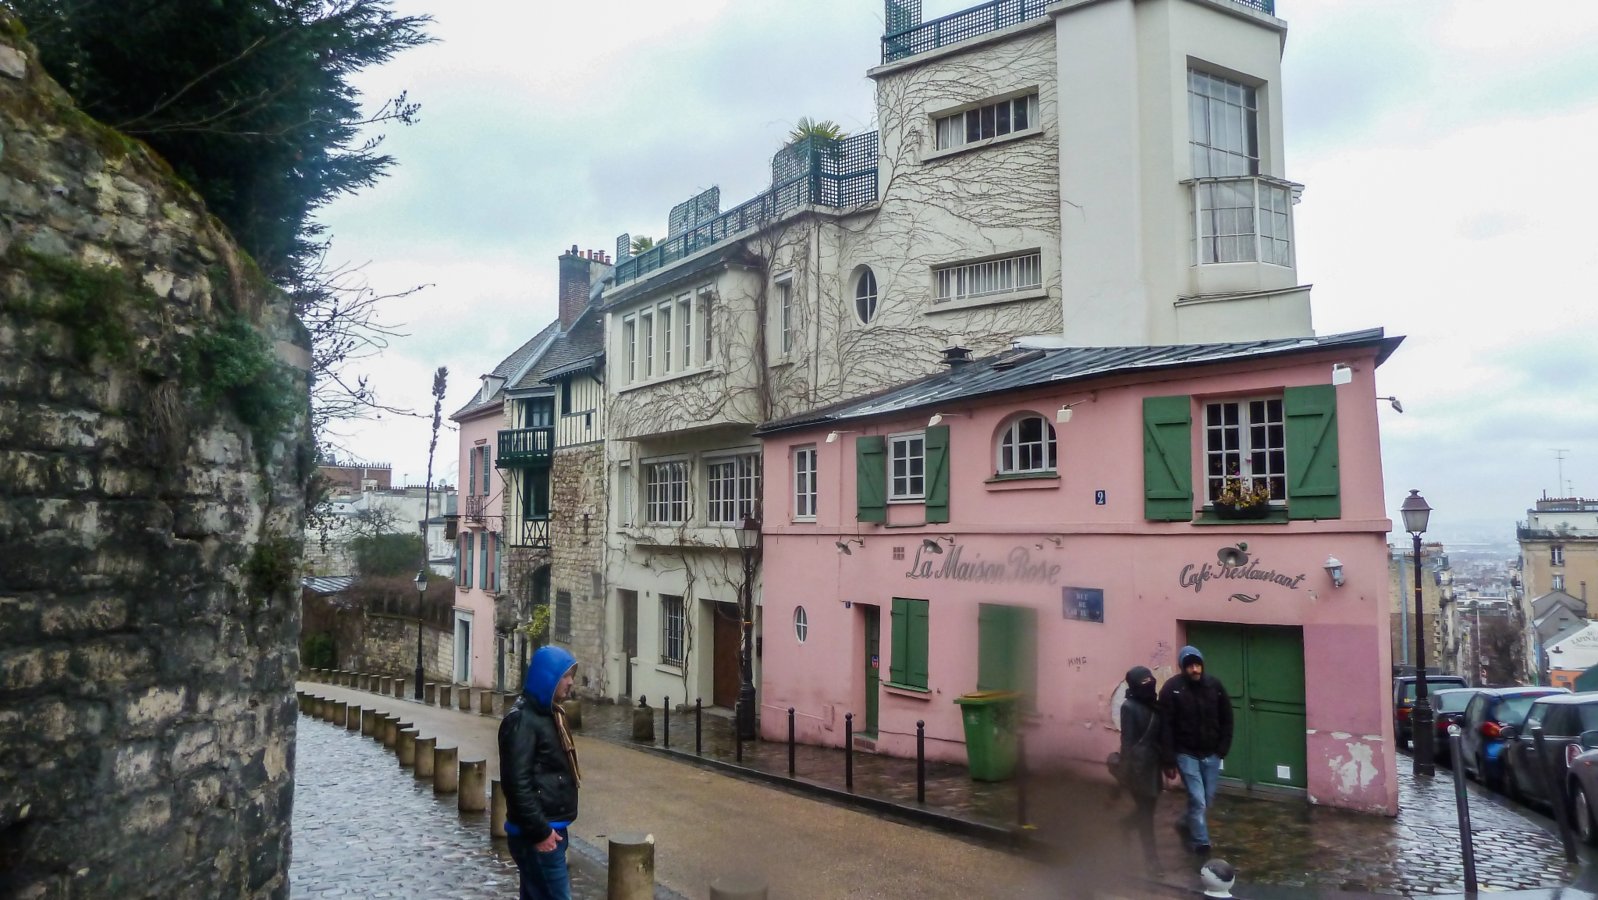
[289,716,604,900]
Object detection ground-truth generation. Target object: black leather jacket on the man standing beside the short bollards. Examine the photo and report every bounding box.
[499,694,577,841]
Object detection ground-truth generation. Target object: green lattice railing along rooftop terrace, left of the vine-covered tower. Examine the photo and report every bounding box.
[607,131,877,287]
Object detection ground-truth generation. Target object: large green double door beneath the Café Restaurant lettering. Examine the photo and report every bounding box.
[1187,622,1307,788]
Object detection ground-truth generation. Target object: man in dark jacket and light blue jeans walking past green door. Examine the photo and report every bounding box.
[1160,646,1232,854]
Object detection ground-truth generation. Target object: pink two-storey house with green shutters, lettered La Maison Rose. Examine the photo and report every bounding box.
[761,329,1400,815]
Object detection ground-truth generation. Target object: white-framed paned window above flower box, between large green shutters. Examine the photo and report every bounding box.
[1203,396,1288,505]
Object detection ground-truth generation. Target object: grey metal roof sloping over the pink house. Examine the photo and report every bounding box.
[756,328,1403,435]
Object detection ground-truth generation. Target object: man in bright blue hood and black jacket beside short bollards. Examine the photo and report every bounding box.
[499,646,582,900]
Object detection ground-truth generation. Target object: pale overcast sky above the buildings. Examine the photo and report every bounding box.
[311,0,1598,542]
